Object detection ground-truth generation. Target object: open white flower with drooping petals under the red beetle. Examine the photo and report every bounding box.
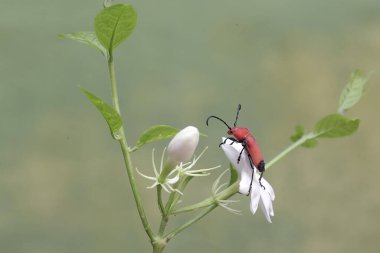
[221,138,275,223]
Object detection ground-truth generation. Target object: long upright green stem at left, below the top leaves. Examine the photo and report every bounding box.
[108,52,154,242]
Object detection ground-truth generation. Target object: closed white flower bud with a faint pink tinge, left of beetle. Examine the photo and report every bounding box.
[168,126,199,163]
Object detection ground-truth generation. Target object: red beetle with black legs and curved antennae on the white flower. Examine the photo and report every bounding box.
[206,104,265,195]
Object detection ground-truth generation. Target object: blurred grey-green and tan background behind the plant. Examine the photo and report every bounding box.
[0,0,380,253]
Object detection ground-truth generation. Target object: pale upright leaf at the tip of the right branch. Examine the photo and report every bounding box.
[338,70,368,113]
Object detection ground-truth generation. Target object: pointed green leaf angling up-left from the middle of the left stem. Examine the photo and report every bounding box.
[81,88,123,140]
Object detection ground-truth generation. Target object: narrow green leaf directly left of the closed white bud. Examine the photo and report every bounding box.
[136,125,179,148]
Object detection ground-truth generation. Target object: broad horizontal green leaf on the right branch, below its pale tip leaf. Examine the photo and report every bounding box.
[314,114,360,138]
